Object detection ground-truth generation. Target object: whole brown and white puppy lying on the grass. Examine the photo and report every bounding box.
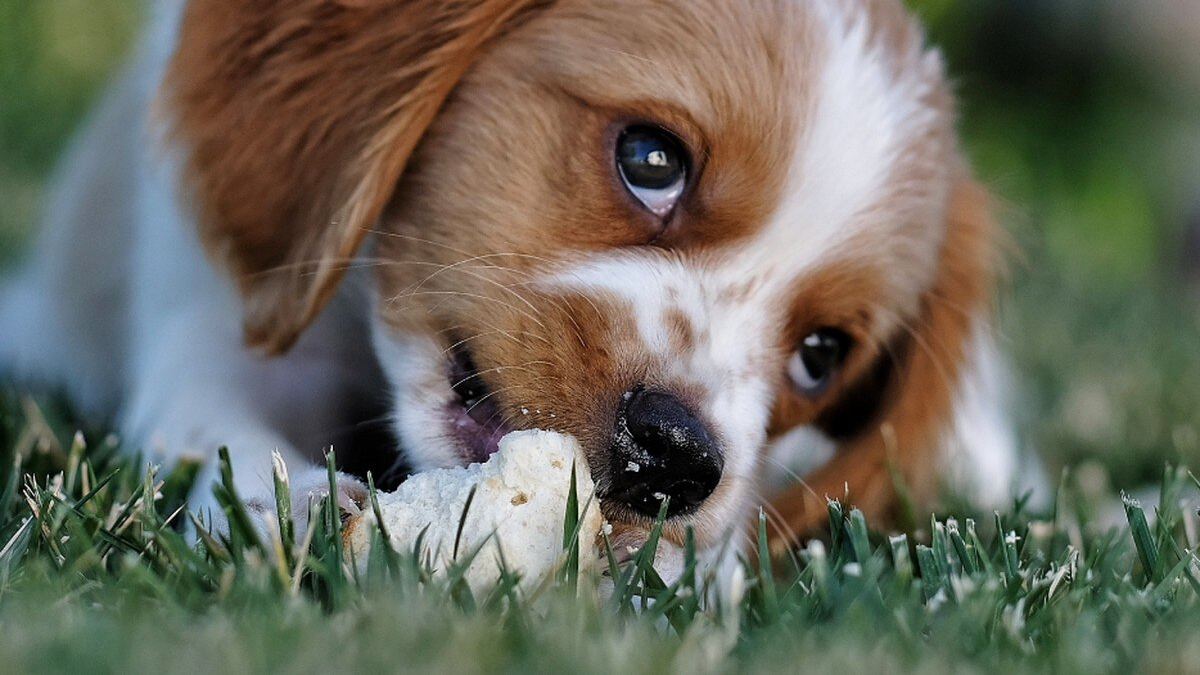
[0,0,1020,550]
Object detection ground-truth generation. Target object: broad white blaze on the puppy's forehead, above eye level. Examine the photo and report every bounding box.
[743,0,946,278]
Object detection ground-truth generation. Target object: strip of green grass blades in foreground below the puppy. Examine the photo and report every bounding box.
[0,392,1200,673]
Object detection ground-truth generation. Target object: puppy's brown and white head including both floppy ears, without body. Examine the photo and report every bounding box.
[166,0,990,543]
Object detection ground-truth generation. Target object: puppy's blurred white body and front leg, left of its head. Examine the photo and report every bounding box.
[0,0,378,508]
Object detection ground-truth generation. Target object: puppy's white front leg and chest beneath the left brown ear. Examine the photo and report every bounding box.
[120,163,372,526]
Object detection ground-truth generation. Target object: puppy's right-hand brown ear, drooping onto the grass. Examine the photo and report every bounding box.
[769,181,998,554]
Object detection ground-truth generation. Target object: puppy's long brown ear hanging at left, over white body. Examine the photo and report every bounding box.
[162,0,547,353]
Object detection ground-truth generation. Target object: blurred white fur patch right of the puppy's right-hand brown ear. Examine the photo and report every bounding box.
[943,322,1052,508]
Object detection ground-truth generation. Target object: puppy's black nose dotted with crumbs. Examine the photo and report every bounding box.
[605,387,725,518]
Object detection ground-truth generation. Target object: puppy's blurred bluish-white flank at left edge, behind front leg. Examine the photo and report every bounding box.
[0,57,143,422]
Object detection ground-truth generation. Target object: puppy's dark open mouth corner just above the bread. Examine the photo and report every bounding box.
[446,342,512,464]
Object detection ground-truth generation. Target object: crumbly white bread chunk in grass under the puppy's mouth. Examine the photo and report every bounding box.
[343,430,602,590]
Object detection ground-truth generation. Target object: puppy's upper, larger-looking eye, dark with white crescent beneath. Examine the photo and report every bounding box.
[617,126,688,217]
